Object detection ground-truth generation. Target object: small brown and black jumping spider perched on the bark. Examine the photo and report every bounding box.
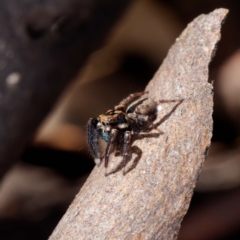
[87,92,178,174]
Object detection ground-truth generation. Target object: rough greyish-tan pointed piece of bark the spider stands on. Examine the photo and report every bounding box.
[50,9,228,240]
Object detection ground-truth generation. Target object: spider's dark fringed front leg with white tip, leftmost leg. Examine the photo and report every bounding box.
[87,118,101,165]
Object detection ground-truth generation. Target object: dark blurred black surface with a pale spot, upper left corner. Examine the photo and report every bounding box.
[0,0,131,178]
